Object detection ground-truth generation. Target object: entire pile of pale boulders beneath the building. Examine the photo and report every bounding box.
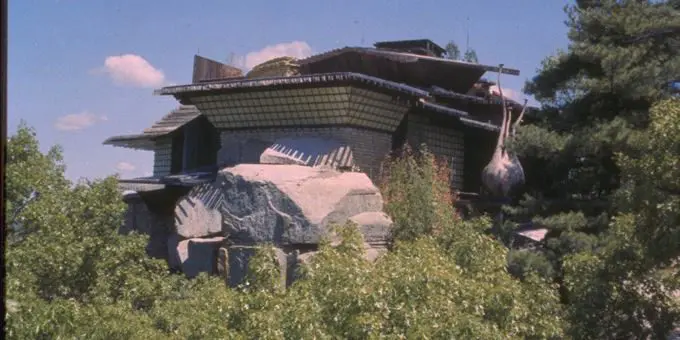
[168,164,392,286]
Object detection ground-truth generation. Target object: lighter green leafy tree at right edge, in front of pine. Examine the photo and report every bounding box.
[565,99,680,338]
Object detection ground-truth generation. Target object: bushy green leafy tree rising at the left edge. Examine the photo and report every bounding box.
[5,123,189,339]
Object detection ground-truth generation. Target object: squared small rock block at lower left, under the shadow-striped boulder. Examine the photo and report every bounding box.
[168,235,224,277]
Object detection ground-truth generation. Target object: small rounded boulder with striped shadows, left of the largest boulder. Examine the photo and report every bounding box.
[175,193,222,238]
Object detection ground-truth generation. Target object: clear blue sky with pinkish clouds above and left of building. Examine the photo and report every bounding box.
[8,0,569,179]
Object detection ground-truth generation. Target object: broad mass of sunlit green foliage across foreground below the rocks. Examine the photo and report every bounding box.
[5,126,564,339]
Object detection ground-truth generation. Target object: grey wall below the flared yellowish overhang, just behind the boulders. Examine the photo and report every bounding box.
[217,127,392,181]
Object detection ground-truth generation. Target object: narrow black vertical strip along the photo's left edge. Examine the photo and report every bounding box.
[0,0,9,314]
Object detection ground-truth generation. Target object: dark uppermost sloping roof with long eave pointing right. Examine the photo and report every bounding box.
[298,47,519,93]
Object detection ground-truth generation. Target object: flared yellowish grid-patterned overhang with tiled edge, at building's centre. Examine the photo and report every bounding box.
[156,73,429,131]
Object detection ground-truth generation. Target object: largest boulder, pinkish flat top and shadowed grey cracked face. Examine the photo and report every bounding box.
[212,164,383,245]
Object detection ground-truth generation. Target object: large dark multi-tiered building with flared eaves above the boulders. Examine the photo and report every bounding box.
[104,40,521,255]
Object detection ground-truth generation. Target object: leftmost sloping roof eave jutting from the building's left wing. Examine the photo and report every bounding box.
[103,105,201,151]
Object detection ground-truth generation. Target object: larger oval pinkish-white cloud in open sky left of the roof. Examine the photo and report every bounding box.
[95,54,165,88]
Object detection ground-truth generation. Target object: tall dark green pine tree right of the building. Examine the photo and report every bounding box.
[505,0,680,310]
